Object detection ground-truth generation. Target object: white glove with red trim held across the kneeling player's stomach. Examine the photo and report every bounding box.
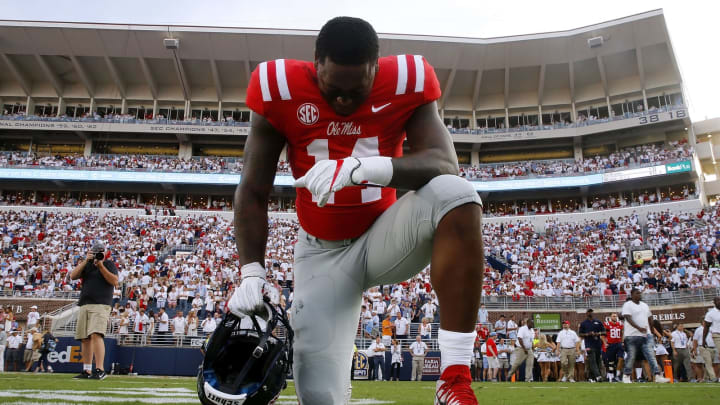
[293,156,393,207]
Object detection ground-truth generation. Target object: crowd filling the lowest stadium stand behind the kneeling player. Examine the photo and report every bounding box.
[0,204,720,308]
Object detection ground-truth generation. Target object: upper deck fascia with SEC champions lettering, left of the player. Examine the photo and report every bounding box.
[0,120,250,135]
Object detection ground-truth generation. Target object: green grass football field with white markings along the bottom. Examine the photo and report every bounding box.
[0,373,720,405]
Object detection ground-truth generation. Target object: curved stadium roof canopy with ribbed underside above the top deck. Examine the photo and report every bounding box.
[0,10,682,111]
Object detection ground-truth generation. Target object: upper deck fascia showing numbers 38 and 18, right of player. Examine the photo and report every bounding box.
[452,108,689,143]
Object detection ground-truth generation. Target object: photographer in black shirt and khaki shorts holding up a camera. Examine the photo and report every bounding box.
[70,242,118,380]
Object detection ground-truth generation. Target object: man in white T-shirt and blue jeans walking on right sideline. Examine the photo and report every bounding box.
[622,288,670,384]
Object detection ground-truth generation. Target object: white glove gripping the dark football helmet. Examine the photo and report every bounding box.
[228,262,280,317]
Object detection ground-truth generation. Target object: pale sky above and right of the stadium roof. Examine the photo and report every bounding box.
[0,0,720,121]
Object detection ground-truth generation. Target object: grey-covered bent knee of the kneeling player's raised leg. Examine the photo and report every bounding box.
[417,174,482,226]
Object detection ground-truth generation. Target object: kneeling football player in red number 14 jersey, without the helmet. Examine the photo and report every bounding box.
[229,17,484,405]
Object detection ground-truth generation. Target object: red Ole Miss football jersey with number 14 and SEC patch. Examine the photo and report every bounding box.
[246,55,443,240]
